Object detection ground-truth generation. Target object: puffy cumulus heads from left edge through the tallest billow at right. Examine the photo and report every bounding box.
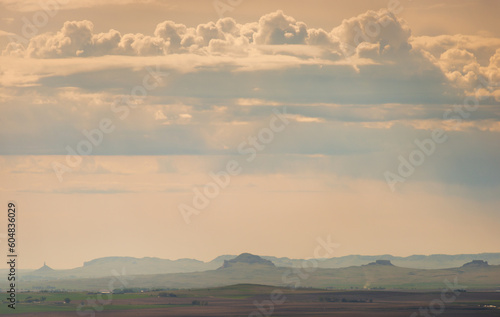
[3,11,411,60]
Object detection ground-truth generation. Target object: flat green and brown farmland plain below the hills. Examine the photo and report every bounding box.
[0,284,500,317]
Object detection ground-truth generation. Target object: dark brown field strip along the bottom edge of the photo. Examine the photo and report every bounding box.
[6,289,500,317]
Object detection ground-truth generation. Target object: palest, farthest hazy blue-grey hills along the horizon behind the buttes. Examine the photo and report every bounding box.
[19,253,500,281]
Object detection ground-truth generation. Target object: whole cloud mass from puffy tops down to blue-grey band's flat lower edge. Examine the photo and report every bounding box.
[0,11,500,175]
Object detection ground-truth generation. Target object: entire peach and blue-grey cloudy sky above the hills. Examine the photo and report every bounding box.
[0,0,500,269]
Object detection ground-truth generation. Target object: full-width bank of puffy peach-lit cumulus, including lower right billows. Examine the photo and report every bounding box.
[3,10,500,103]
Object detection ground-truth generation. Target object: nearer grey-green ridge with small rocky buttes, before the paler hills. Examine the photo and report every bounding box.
[13,253,500,291]
